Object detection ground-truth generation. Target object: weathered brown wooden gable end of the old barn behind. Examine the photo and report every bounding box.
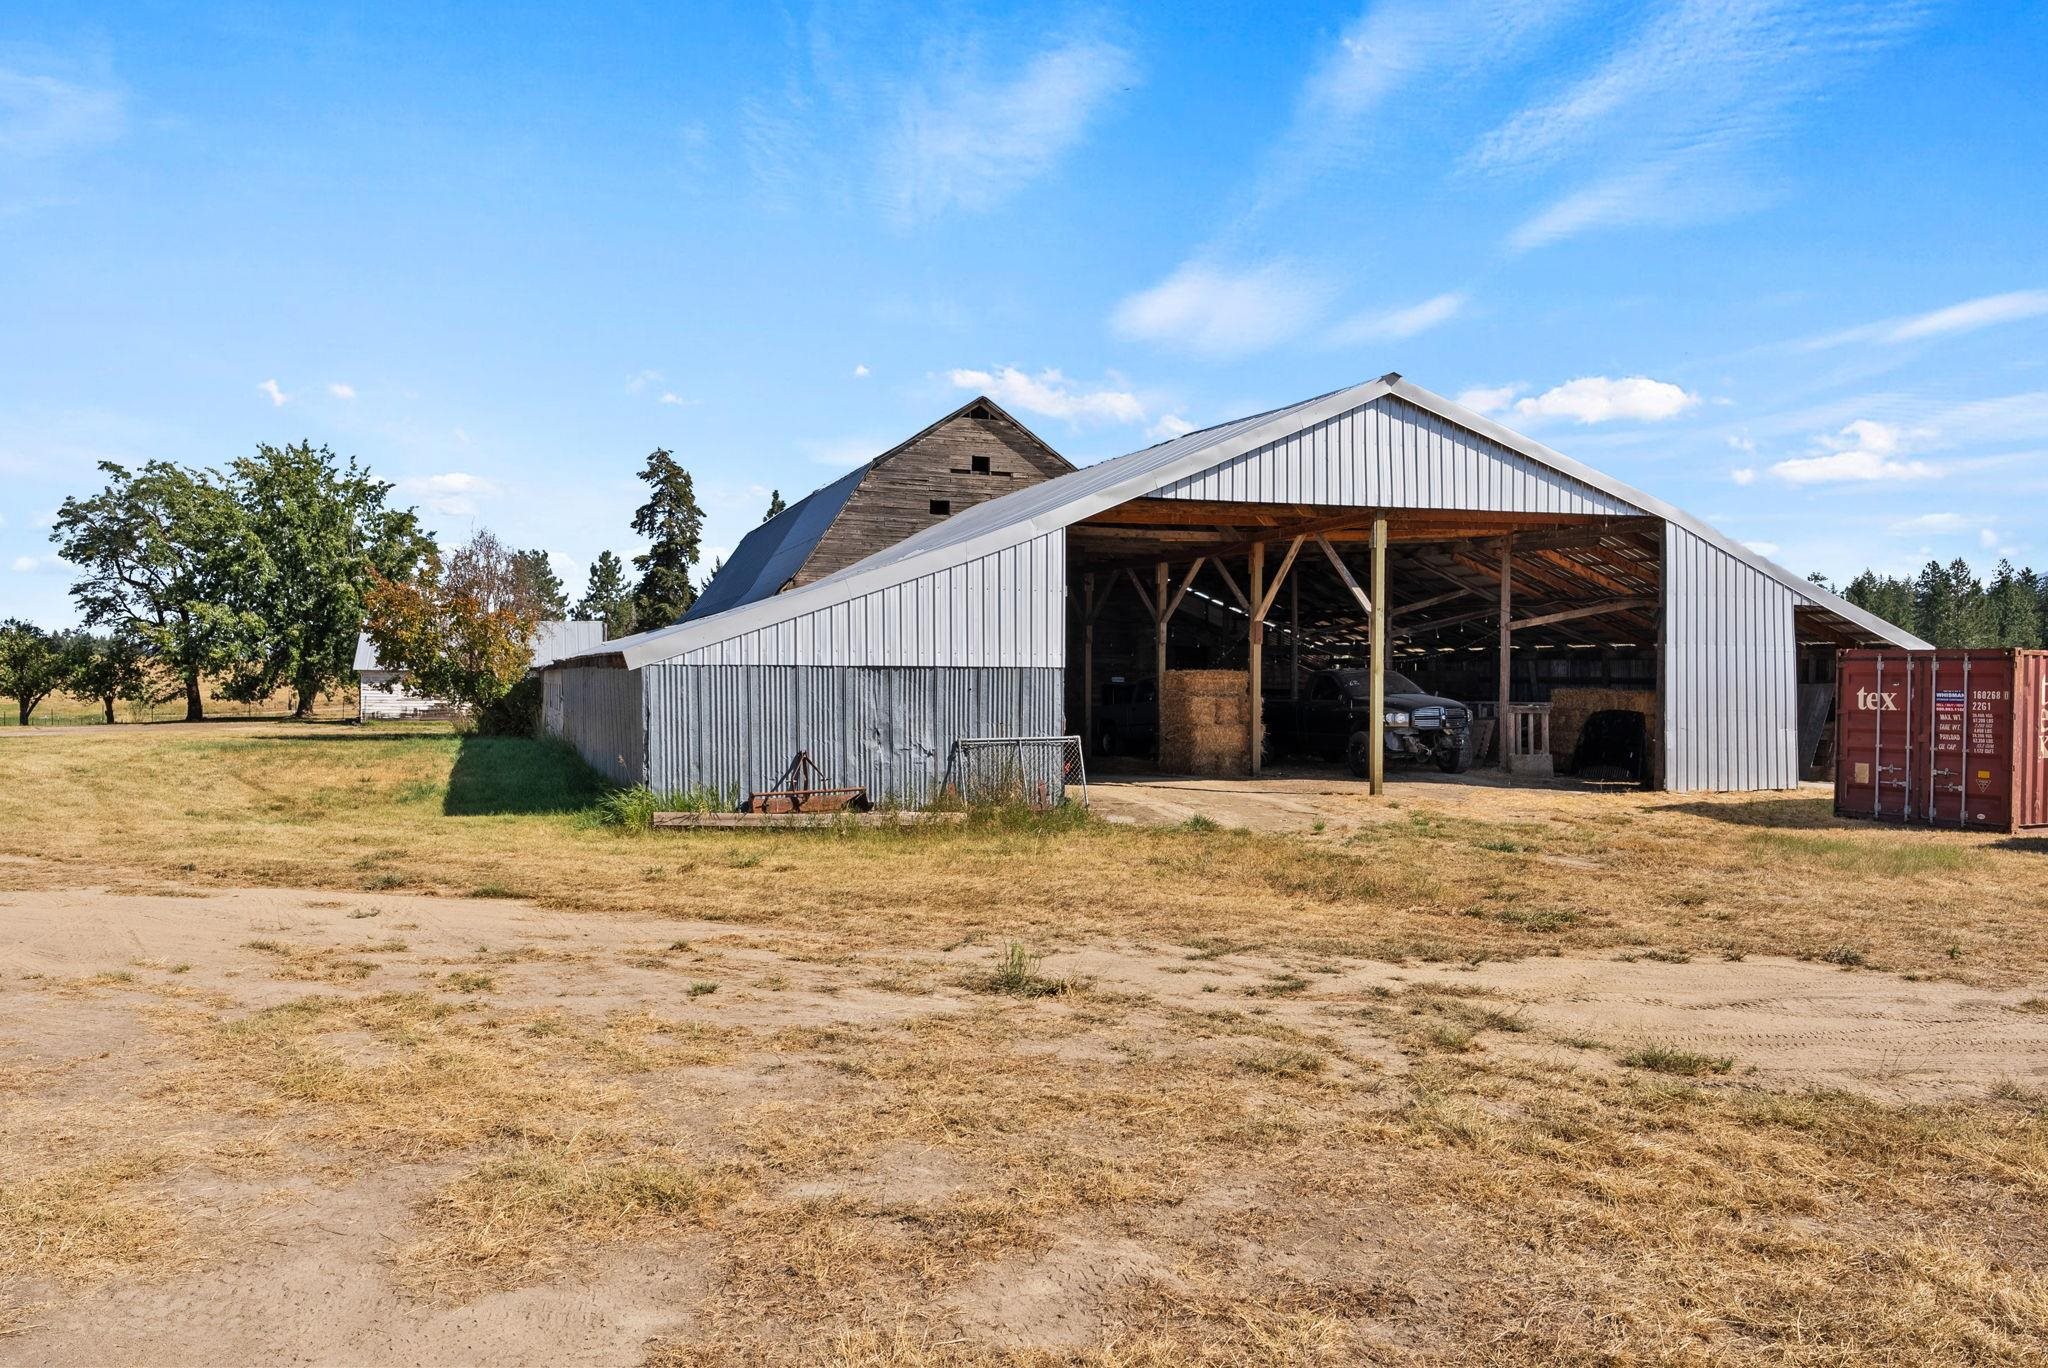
[791,410,1073,588]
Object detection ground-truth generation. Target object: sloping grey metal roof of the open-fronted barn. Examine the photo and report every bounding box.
[585,375,1925,670]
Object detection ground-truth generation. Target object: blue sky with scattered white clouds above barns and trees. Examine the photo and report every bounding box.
[0,0,2048,623]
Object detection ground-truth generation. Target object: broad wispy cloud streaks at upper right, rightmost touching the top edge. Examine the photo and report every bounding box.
[1464,0,1925,250]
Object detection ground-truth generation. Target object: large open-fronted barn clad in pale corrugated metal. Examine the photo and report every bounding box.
[545,375,1921,803]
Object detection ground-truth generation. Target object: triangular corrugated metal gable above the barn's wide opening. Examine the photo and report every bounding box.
[1159,395,1640,514]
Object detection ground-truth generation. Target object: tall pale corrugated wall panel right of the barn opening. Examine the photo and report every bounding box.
[1663,524,1798,793]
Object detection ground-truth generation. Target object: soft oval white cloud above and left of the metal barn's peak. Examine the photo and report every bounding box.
[1110,262,1327,356]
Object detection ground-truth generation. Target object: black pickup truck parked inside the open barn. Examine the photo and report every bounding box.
[1264,670,1473,776]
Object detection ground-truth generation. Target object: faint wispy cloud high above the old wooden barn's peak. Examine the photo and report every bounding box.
[881,39,1137,223]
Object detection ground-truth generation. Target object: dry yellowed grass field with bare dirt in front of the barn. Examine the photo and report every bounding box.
[0,725,2048,1368]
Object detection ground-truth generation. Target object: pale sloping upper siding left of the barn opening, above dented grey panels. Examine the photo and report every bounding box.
[674,530,1067,670]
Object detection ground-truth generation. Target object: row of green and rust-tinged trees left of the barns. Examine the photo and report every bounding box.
[0,442,753,725]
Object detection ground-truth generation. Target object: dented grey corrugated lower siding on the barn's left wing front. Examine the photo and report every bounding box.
[635,661,1065,805]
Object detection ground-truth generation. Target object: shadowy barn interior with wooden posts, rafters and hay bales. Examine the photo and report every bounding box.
[1067,498,1853,786]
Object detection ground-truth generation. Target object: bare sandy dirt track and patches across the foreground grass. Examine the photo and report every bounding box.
[0,880,2048,1364]
